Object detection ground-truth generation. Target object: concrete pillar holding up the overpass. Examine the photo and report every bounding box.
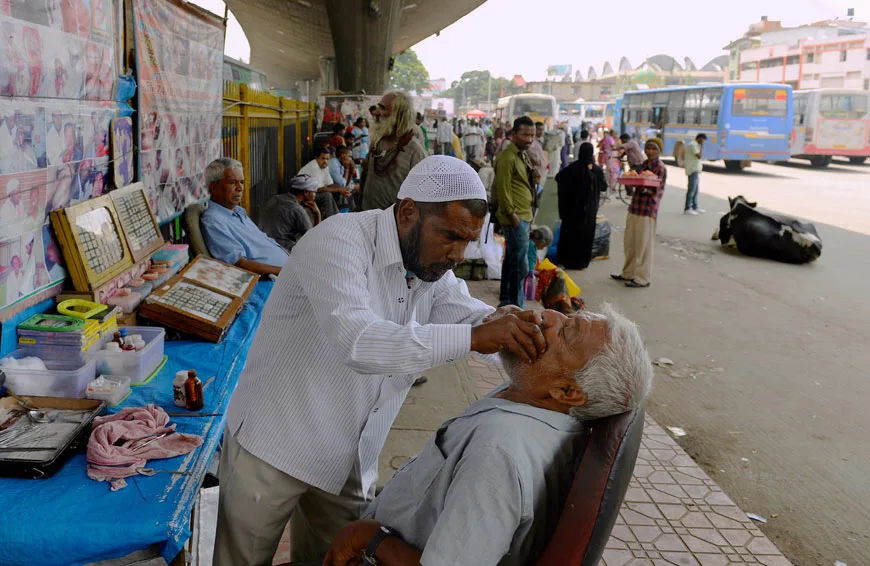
[326,0,404,94]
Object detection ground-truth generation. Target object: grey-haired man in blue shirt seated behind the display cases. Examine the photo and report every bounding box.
[200,157,288,275]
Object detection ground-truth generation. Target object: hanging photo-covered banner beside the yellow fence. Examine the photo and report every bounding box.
[133,0,224,226]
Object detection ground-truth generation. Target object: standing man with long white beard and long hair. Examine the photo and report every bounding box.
[360,91,426,210]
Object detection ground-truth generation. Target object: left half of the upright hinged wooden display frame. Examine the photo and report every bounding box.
[51,195,134,291]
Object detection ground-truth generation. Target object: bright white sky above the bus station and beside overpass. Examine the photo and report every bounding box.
[194,0,870,84]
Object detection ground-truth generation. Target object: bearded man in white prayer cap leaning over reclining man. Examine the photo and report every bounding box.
[214,155,546,566]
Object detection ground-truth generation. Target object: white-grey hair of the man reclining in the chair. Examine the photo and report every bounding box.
[570,303,654,421]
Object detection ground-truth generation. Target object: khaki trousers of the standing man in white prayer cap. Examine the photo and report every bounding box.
[214,429,374,566]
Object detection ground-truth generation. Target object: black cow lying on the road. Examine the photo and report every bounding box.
[712,196,822,263]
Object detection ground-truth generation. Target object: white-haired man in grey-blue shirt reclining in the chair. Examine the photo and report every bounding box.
[324,305,653,566]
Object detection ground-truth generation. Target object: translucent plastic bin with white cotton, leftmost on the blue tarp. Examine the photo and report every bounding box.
[0,350,97,399]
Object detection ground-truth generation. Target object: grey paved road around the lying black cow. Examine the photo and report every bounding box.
[572,162,870,566]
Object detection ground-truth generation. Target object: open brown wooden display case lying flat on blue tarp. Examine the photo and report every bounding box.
[139,255,258,342]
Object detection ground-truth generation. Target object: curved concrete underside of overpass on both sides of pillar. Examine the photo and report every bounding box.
[226,0,486,89]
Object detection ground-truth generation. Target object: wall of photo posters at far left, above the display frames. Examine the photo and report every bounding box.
[0,0,119,315]
